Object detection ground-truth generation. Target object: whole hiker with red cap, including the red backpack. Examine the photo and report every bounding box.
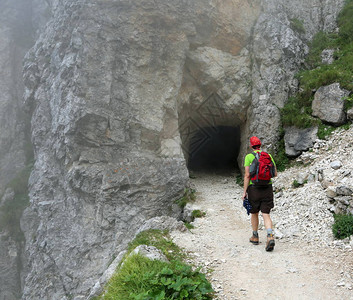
[243,136,277,251]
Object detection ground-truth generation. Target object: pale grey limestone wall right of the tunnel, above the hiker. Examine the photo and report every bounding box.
[242,0,344,159]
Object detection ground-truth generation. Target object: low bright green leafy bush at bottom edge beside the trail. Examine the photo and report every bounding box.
[102,255,213,300]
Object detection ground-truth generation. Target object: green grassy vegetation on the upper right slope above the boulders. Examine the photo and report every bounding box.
[281,0,353,128]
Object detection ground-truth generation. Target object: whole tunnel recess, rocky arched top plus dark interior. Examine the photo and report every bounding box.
[179,93,246,174]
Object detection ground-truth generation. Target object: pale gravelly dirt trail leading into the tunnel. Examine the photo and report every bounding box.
[172,174,353,300]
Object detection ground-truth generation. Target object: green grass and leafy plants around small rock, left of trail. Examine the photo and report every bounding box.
[98,230,213,300]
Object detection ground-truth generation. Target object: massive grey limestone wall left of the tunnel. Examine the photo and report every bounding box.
[22,1,188,299]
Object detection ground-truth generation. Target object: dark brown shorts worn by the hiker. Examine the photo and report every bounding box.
[248,184,274,214]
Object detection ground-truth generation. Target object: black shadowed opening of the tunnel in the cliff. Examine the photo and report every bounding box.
[188,126,240,175]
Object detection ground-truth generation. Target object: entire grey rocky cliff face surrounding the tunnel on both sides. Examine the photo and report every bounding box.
[0,0,343,299]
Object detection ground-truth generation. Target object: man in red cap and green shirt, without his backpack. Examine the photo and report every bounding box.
[243,136,277,251]
